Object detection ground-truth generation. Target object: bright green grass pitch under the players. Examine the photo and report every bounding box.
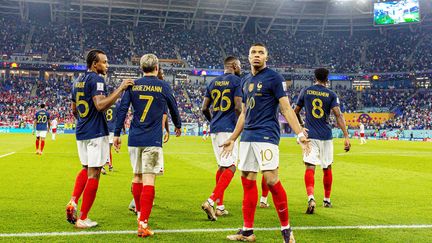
[0,134,432,242]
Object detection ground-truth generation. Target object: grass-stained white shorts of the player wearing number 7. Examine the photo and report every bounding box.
[128,147,164,175]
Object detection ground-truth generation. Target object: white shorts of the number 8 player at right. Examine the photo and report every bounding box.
[303,139,333,169]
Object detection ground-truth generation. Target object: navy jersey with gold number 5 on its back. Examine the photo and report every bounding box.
[72,72,108,140]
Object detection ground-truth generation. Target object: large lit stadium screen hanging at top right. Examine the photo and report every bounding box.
[374,0,420,26]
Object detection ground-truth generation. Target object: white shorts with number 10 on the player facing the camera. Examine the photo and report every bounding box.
[238,142,279,172]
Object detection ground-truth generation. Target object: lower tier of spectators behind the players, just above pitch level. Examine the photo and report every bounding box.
[0,76,432,133]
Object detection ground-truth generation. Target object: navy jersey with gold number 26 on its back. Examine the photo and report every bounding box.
[205,73,242,133]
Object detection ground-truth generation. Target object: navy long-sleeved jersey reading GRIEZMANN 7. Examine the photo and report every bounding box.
[114,76,181,147]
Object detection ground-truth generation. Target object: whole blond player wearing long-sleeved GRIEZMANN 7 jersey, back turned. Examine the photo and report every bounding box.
[114,54,181,237]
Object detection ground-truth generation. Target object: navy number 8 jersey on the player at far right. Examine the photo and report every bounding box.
[297,85,339,140]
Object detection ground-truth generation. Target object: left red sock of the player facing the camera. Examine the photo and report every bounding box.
[242,177,258,228]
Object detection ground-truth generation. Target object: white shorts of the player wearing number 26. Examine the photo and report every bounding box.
[210,132,238,167]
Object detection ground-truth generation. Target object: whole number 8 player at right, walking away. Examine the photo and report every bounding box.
[294,68,351,214]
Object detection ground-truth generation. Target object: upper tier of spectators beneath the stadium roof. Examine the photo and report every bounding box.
[0,19,432,73]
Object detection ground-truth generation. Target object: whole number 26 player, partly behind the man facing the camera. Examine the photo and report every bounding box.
[201,56,242,221]
